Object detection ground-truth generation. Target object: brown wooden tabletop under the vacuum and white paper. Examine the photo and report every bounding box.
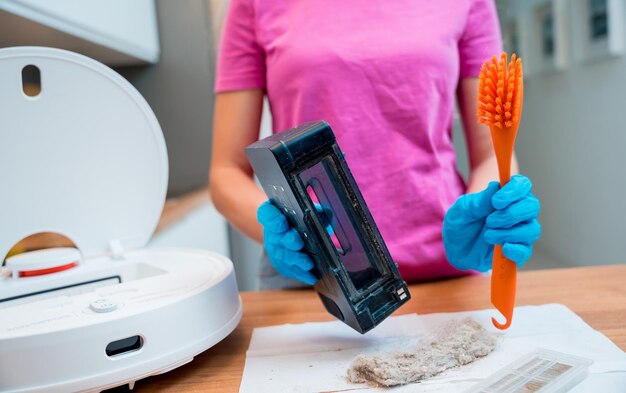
[125,265,626,392]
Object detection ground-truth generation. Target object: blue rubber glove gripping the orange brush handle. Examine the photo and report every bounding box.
[443,175,541,272]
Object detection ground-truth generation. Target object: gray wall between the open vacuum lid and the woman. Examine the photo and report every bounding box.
[117,0,215,195]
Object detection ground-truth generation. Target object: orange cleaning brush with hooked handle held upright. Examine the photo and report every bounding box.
[478,53,524,329]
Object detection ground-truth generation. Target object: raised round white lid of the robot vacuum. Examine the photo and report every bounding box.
[0,47,168,260]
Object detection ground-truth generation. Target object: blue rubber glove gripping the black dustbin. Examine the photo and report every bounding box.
[257,201,317,285]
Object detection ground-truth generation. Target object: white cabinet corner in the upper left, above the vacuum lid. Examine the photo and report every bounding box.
[0,0,159,66]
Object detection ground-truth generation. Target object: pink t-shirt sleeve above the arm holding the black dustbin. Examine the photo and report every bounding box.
[215,0,265,93]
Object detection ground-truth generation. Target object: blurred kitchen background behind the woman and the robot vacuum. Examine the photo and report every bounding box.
[0,0,626,290]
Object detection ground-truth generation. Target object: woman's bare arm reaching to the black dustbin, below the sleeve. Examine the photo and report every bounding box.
[209,89,267,242]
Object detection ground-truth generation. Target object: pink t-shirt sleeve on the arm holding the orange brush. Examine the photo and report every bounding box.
[459,0,502,78]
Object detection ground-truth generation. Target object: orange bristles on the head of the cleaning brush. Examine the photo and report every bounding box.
[478,53,524,128]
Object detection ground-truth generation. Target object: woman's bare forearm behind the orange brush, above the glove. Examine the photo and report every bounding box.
[457,78,518,193]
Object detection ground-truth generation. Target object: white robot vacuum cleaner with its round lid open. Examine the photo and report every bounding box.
[0,47,242,392]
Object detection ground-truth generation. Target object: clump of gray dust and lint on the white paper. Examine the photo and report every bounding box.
[348,318,497,386]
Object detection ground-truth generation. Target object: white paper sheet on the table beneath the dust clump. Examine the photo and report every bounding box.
[239,304,626,393]
